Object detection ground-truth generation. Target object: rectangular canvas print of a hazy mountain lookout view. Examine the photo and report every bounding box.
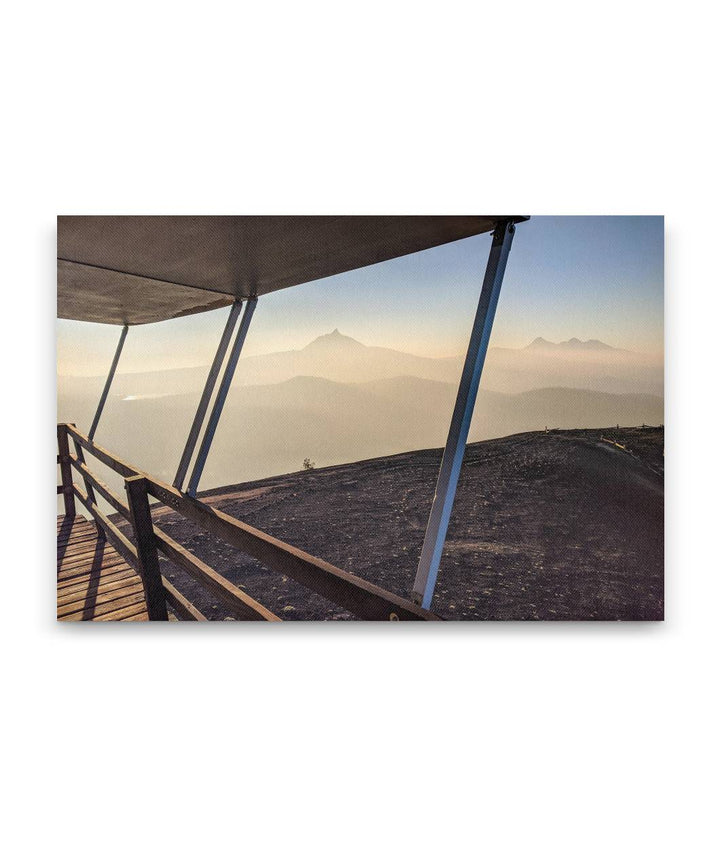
[57,214,664,622]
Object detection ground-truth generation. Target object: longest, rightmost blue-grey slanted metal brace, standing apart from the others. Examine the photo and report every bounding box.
[412,220,515,609]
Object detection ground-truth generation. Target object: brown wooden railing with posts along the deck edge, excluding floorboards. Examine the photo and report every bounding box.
[57,424,436,621]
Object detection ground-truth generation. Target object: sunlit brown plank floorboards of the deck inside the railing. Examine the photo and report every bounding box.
[57,516,148,621]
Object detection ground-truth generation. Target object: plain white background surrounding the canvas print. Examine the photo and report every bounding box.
[0,0,720,854]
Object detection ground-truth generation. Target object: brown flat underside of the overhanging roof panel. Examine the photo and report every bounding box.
[57,215,526,324]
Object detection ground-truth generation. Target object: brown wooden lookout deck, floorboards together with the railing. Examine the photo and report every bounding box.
[57,423,438,622]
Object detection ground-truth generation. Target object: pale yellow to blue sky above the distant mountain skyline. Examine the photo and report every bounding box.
[57,216,663,375]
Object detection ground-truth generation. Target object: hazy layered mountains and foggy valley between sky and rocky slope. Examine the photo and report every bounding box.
[58,330,663,508]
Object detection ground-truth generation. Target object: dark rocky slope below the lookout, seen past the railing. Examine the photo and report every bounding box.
[119,428,663,620]
